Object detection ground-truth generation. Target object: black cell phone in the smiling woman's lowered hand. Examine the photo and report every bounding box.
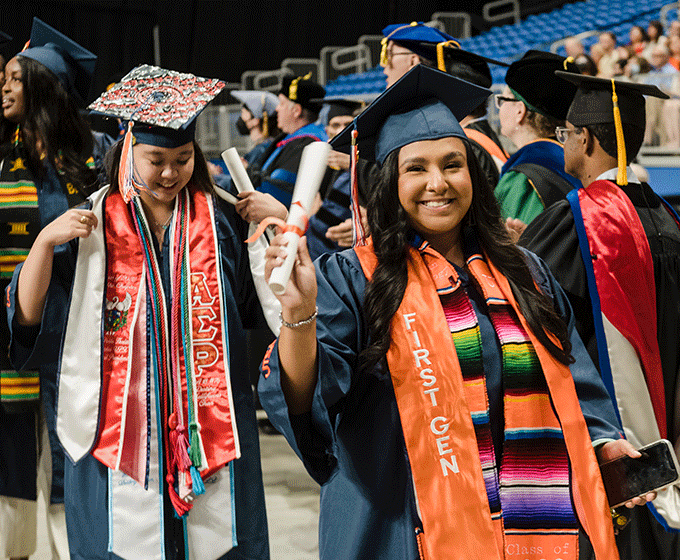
[600,439,680,508]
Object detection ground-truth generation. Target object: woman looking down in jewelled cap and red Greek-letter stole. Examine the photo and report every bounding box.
[8,66,269,560]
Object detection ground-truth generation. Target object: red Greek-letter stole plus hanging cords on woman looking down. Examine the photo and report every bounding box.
[92,188,240,516]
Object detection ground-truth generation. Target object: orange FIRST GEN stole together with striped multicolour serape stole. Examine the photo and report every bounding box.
[354,242,618,560]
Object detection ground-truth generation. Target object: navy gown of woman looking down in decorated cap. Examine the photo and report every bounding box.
[8,191,269,560]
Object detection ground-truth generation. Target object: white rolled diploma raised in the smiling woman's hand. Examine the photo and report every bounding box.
[269,142,331,294]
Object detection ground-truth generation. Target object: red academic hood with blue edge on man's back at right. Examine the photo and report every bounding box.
[567,181,666,440]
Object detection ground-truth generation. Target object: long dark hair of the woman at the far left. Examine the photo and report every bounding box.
[0,56,99,196]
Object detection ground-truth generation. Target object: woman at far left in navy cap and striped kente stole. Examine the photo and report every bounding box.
[0,18,99,560]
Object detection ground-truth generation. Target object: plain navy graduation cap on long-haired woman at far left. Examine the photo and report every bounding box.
[17,18,97,103]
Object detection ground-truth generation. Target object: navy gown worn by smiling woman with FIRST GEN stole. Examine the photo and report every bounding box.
[258,242,620,560]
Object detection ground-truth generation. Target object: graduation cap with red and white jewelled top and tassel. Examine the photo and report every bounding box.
[89,65,226,202]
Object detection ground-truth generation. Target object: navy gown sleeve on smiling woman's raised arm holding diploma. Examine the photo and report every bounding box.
[258,251,367,484]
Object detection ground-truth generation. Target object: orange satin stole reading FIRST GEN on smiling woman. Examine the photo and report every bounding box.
[354,240,619,560]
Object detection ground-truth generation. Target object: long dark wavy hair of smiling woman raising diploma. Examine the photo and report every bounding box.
[360,140,574,369]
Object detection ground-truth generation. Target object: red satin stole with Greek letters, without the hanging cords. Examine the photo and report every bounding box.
[92,190,239,484]
